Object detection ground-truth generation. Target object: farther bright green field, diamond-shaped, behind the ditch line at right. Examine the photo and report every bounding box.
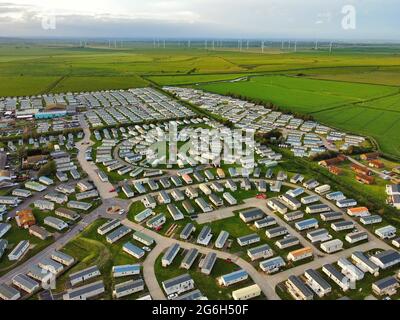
[201,76,399,114]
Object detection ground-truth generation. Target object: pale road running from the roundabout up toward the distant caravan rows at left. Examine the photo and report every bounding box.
[76,115,118,200]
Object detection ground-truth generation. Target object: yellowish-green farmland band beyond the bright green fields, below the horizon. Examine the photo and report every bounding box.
[0,44,400,96]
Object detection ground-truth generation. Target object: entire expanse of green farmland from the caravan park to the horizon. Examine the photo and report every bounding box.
[0,42,400,156]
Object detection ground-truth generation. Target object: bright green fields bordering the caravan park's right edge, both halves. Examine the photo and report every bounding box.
[200,76,400,156]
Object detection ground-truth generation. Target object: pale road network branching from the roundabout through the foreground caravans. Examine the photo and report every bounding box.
[0,172,391,300]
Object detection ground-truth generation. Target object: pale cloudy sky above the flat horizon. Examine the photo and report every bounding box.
[0,0,400,41]
